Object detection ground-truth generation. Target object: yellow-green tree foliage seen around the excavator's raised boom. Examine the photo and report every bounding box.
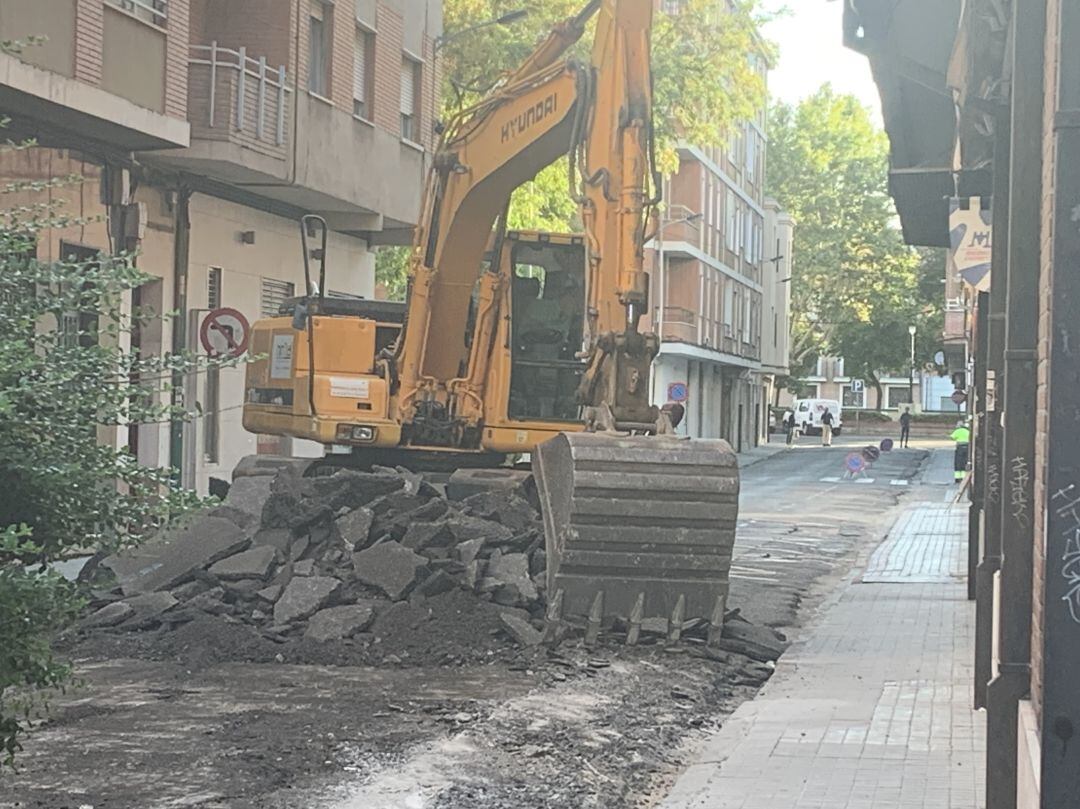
[442,0,772,226]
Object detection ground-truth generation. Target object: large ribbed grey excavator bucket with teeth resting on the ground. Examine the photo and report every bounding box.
[532,433,739,643]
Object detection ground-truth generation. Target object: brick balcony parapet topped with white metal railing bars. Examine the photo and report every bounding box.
[188,41,293,159]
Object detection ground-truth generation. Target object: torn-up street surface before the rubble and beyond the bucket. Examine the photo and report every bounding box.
[0,442,923,809]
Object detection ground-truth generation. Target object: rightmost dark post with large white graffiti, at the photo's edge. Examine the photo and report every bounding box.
[1035,0,1080,794]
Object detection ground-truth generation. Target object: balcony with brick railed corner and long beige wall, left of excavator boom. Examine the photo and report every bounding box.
[156,41,426,241]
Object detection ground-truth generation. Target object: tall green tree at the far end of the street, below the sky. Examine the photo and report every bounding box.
[767,85,942,401]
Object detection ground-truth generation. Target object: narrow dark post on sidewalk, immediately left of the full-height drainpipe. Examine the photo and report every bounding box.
[974,102,1011,709]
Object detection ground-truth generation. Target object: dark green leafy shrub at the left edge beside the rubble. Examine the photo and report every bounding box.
[0,156,225,764]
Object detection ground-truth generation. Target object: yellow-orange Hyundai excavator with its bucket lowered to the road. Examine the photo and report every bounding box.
[244,0,739,641]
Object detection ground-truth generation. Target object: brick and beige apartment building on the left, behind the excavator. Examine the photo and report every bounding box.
[0,0,442,493]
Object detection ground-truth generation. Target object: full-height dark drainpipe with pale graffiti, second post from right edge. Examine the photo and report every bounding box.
[986,0,1047,809]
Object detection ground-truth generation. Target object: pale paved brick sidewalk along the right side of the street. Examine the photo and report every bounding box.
[662,503,986,809]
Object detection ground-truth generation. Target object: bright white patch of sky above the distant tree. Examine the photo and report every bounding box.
[762,0,881,122]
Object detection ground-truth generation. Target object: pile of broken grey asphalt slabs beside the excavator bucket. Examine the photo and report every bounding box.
[81,462,544,653]
